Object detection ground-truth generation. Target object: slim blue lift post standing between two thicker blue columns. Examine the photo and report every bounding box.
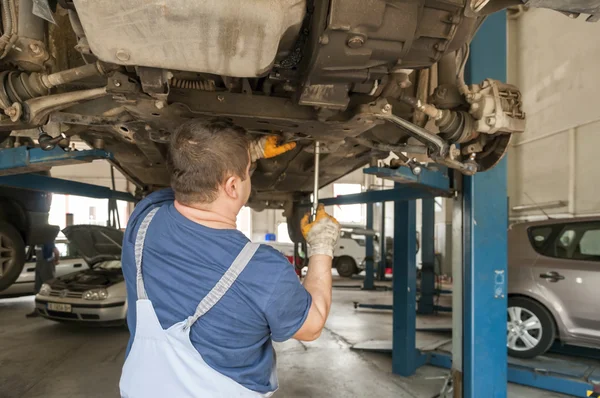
[417,198,435,315]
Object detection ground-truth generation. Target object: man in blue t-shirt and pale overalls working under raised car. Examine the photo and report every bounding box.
[120,120,340,398]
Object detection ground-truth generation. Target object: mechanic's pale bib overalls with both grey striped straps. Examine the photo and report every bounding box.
[119,208,277,398]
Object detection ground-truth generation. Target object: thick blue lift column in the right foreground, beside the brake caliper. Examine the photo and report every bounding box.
[460,11,508,398]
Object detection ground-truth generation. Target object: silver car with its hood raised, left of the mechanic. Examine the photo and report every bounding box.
[35,225,127,324]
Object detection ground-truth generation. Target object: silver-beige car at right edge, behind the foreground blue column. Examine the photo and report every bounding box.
[507,217,600,358]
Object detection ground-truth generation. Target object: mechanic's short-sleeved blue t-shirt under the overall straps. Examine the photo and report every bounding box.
[122,189,312,393]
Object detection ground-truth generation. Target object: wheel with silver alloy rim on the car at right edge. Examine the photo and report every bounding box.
[506,297,556,358]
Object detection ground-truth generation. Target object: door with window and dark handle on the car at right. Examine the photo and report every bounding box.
[532,222,600,344]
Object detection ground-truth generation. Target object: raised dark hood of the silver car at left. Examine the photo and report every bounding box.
[62,225,123,267]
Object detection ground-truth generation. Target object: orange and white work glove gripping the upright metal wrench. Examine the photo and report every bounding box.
[300,205,341,258]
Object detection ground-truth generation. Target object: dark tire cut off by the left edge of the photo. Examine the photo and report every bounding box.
[0,221,25,291]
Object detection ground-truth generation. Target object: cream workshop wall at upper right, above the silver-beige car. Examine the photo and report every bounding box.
[509,9,600,218]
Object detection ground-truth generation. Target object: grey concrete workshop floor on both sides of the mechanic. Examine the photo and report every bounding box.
[0,282,562,398]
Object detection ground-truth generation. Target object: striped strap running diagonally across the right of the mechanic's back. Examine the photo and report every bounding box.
[185,242,260,329]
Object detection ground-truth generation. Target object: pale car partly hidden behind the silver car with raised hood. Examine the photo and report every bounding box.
[0,240,87,297]
